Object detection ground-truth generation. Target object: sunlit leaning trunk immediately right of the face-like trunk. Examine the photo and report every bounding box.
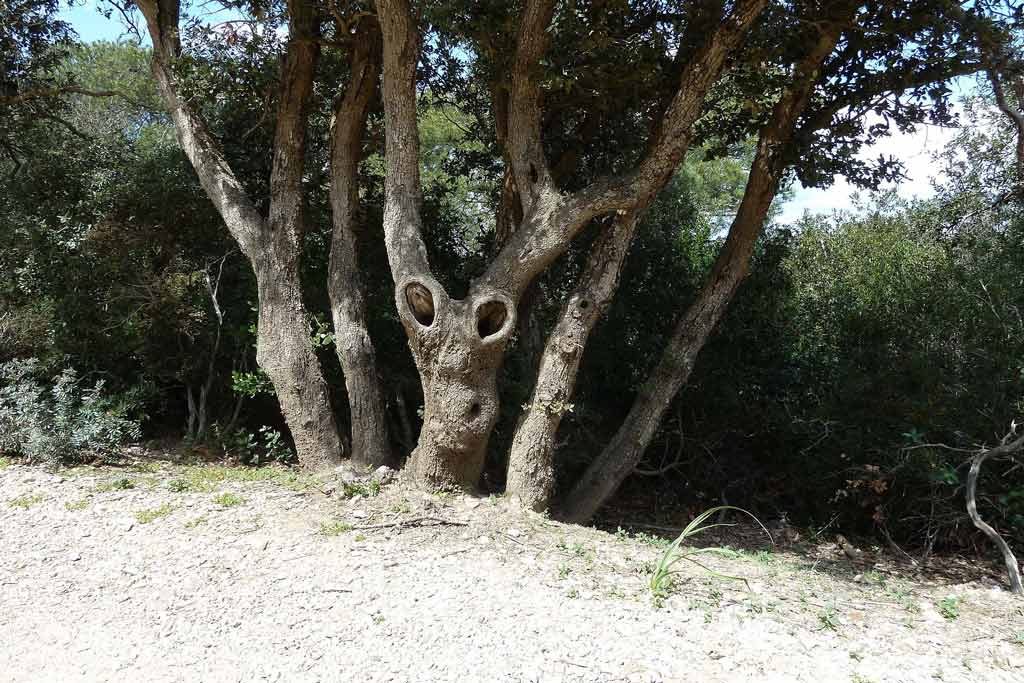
[505,213,638,511]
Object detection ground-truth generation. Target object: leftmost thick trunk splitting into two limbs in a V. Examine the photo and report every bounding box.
[136,0,343,469]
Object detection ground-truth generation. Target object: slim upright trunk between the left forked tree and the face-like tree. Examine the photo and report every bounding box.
[328,16,392,467]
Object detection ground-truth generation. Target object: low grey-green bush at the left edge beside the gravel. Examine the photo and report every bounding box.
[0,359,141,464]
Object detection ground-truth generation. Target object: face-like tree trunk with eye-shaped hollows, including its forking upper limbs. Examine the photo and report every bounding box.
[377,0,767,488]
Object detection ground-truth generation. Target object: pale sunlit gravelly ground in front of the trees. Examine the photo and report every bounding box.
[0,460,1024,683]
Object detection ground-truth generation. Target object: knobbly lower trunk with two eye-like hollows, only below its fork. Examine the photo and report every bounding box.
[396,276,515,490]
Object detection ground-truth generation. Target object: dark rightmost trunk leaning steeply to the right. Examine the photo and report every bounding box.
[560,21,852,523]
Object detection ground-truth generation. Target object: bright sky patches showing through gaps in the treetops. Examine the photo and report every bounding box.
[61,0,972,222]
